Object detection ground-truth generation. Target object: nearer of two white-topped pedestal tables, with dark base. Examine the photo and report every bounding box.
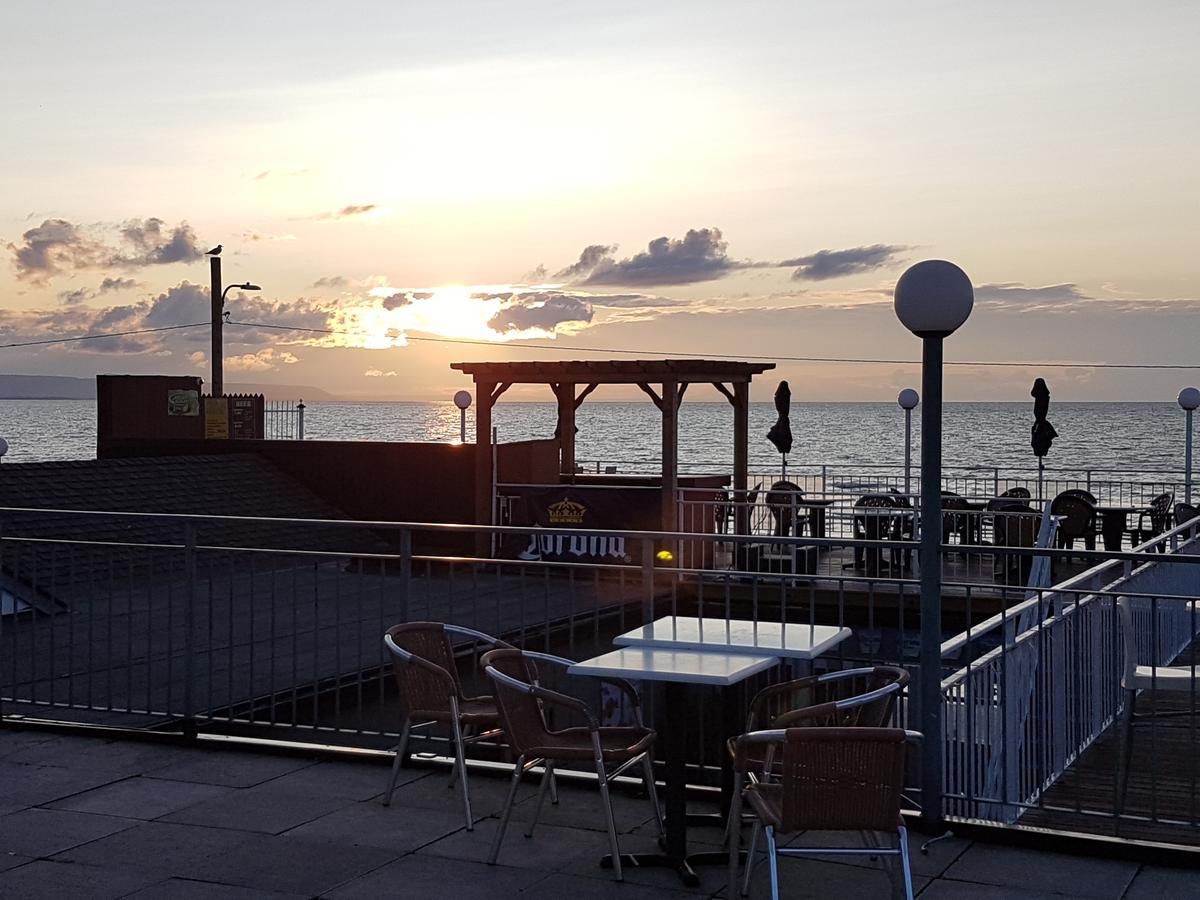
[568,644,779,887]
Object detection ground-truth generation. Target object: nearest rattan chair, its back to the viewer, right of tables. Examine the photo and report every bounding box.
[728,727,920,900]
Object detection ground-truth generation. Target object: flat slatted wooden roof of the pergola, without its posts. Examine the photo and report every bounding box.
[450,359,775,384]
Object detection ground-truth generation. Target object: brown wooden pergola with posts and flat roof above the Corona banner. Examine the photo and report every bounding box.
[450,359,775,533]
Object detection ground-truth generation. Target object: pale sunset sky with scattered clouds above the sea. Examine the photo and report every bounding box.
[0,0,1200,401]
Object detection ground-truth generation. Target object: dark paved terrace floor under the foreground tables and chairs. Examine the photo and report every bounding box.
[0,728,1200,900]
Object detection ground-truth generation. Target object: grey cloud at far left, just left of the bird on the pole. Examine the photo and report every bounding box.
[8,217,203,284]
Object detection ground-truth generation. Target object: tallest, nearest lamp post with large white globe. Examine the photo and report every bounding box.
[895,259,974,826]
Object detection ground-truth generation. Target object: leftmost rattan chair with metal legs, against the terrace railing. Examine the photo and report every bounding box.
[383,622,509,832]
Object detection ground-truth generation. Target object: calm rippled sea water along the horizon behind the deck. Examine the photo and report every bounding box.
[0,400,1184,473]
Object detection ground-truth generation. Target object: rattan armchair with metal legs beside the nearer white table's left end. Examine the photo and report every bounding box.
[480,649,664,881]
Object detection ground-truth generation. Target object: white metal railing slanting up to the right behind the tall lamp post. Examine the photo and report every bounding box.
[942,523,1200,824]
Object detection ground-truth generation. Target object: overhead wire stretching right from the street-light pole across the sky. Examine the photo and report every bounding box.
[226,322,1200,370]
